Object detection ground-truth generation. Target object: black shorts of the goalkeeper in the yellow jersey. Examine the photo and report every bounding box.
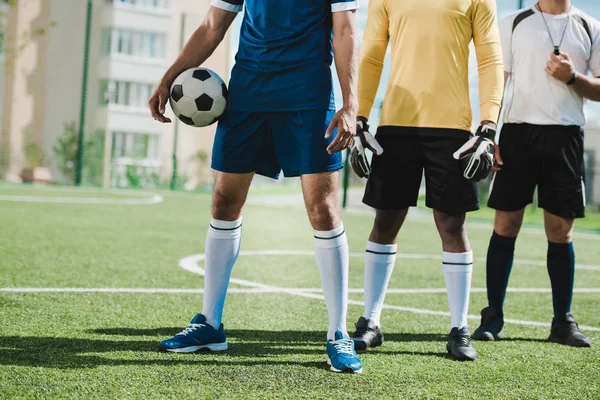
[363,126,479,215]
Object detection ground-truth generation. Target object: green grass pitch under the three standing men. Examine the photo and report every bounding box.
[0,185,600,399]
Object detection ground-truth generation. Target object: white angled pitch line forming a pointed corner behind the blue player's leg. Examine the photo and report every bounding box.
[179,250,600,332]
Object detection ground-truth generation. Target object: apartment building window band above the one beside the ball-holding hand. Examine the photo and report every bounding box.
[101,28,167,59]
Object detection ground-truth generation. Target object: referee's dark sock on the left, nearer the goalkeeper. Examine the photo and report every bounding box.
[486,232,517,316]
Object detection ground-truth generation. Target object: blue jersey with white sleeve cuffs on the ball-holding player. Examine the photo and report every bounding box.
[212,0,358,112]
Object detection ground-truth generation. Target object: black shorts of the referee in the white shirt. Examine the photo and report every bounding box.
[488,124,585,219]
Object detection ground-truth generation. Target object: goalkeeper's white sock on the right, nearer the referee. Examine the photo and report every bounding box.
[442,251,473,329]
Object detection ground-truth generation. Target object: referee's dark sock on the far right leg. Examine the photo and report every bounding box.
[548,242,575,320]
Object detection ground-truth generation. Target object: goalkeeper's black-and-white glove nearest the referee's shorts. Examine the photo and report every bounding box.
[454,123,496,182]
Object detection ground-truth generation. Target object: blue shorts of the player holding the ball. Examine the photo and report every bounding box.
[211,110,342,179]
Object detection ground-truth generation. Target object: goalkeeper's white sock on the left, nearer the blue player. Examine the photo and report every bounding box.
[363,241,398,326]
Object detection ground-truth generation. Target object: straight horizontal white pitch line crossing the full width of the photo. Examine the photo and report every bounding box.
[0,286,600,294]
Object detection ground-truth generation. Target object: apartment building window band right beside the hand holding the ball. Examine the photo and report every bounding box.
[99,80,154,107]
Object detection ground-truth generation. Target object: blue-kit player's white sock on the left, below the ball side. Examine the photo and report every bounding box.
[202,218,242,329]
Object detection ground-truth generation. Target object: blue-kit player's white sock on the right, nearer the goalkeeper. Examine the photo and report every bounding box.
[315,225,350,340]
